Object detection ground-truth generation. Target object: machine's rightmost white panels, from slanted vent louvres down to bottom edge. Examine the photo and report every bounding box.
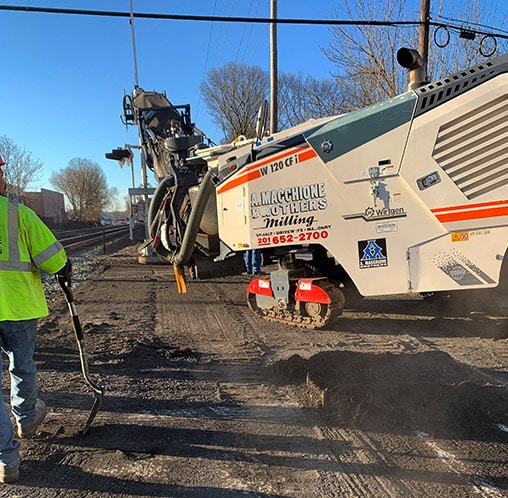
[401,73,508,292]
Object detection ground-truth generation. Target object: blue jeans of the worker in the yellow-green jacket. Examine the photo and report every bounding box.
[0,320,37,465]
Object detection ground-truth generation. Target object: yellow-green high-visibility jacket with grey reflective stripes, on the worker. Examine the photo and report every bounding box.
[0,196,67,321]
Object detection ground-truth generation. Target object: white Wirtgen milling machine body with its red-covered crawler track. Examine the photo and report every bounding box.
[204,55,508,328]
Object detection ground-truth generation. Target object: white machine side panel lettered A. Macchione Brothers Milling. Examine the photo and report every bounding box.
[217,130,444,295]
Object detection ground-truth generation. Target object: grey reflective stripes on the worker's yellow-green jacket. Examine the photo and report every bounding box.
[0,202,63,272]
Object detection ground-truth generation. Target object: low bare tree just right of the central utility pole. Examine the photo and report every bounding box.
[278,72,343,129]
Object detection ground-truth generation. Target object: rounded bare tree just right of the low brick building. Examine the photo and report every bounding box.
[49,158,110,224]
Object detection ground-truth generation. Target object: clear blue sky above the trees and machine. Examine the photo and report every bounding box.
[0,0,504,204]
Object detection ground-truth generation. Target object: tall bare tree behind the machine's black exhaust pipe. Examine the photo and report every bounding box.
[323,0,506,111]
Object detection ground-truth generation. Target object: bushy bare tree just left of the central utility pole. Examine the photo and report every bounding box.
[201,62,269,142]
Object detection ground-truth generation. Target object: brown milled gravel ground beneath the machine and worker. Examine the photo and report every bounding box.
[0,234,508,498]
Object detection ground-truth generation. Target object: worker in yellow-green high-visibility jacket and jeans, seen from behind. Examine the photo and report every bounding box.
[0,157,72,483]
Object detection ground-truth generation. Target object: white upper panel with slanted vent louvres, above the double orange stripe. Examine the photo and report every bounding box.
[401,74,508,212]
